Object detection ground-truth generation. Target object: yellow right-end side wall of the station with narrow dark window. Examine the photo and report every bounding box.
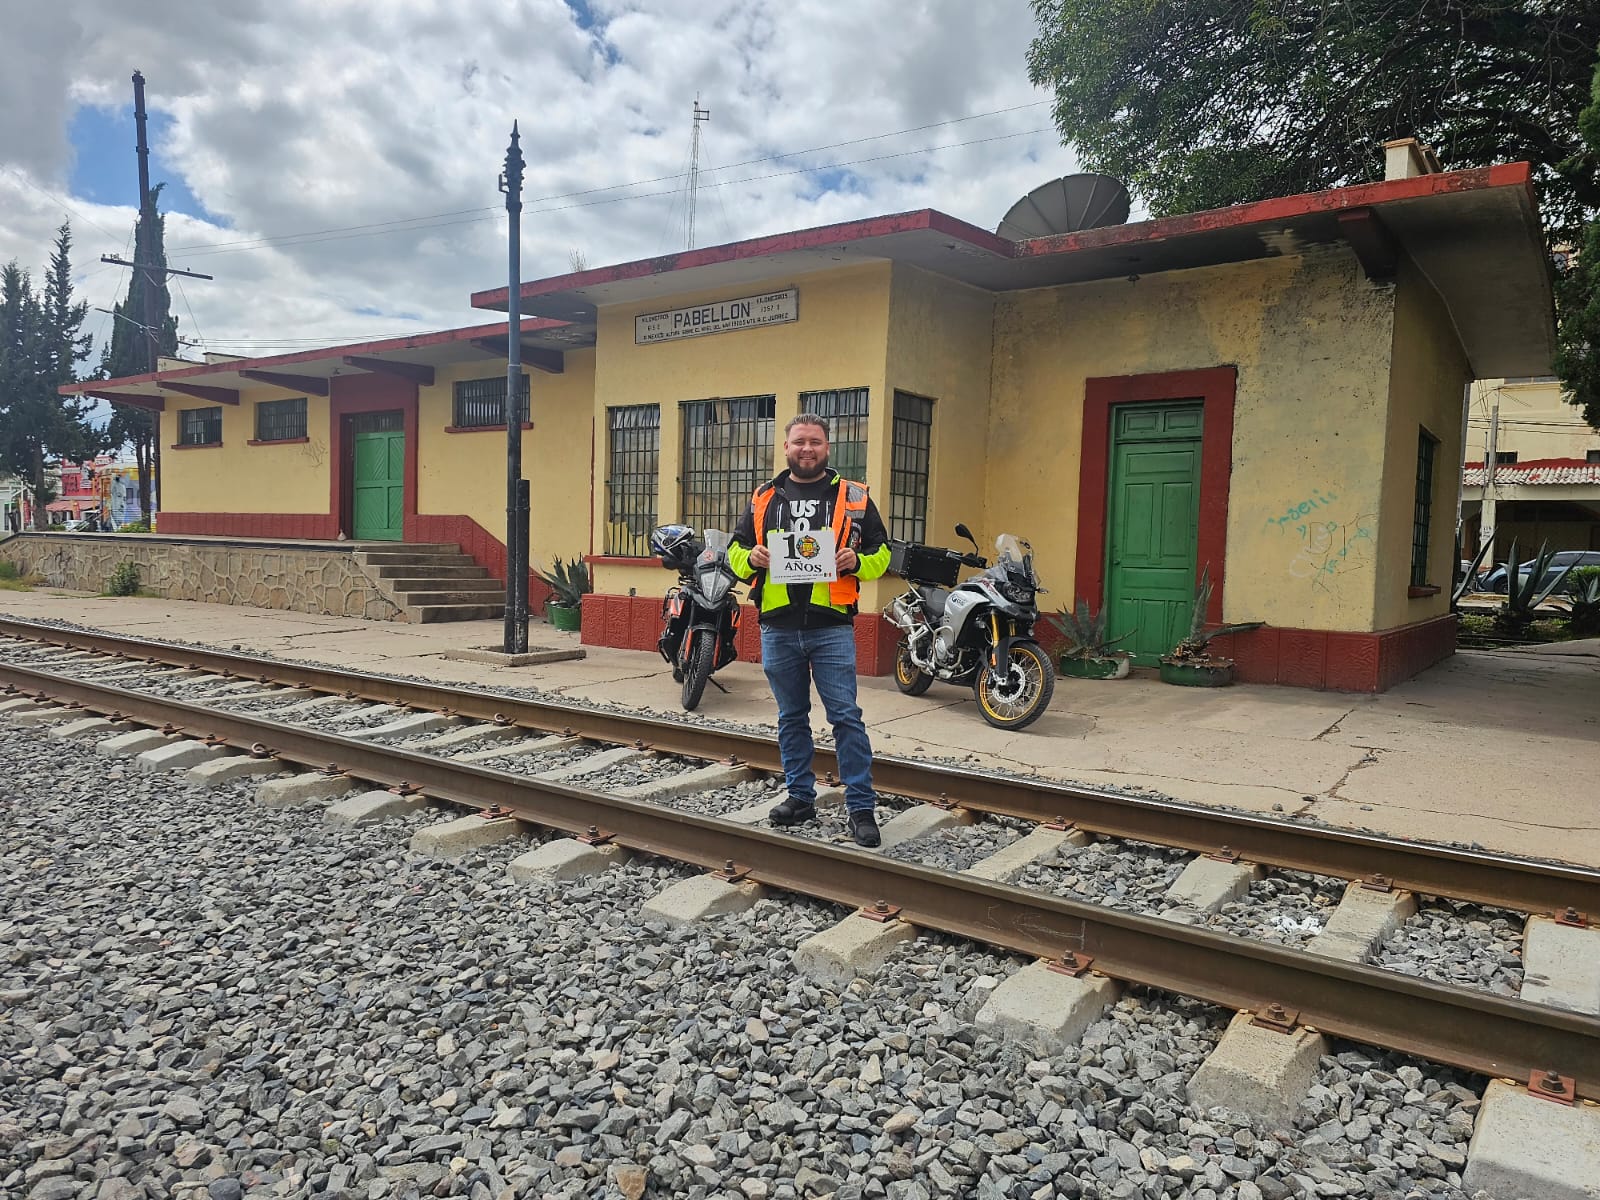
[1373,259,1469,629]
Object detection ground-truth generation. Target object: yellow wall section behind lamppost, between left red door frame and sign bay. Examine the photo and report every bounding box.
[416,350,595,568]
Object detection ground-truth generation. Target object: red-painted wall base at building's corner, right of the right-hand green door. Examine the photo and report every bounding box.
[1211,614,1456,691]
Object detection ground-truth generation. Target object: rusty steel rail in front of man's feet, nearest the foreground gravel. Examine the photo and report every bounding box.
[0,652,1600,1099]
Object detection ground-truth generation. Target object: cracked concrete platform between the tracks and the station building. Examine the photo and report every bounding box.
[0,589,1600,866]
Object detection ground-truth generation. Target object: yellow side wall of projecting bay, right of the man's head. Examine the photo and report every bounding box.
[874,266,995,563]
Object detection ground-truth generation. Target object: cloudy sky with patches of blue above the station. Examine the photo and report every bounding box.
[0,0,1074,377]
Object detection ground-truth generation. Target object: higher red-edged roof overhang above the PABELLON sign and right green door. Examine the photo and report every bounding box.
[472,163,1555,378]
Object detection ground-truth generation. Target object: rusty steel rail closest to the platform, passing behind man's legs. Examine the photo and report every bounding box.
[0,618,1600,914]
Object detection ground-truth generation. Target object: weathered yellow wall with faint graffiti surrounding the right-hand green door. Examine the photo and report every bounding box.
[984,248,1392,630]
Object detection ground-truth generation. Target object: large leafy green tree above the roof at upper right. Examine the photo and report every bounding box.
[1027,0,1600,427]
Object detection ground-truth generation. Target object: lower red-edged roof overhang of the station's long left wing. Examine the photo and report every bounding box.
[59,317,594,413]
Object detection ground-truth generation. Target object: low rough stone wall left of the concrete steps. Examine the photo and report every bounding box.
[0,533,406,621]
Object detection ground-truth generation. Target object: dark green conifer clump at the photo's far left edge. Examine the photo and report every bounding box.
[0,224,101,528]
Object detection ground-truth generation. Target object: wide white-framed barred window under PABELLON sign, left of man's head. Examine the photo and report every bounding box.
[678,395,776,533]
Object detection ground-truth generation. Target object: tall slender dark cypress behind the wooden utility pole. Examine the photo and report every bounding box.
[99,184,178,522]
